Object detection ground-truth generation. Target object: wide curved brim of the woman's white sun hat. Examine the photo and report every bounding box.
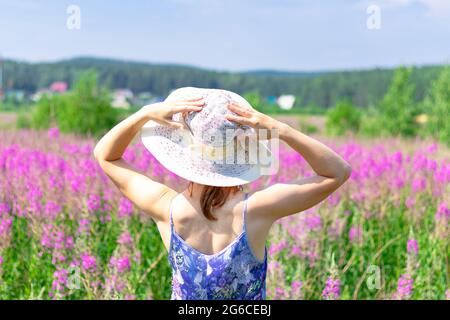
[141,120,276,187]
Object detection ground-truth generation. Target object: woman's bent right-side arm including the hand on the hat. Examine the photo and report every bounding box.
[228,105,351,224]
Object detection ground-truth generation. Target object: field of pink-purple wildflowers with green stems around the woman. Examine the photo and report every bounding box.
[0,128,450,299]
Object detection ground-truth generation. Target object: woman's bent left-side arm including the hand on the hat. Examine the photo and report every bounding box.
[94,99,203,221]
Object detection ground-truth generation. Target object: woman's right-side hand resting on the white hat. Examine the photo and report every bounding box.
[226,103,285,139]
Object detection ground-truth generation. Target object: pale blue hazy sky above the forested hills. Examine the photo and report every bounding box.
[0,0,450,71]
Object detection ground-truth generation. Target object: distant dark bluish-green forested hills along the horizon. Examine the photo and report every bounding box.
[4,58,443,108]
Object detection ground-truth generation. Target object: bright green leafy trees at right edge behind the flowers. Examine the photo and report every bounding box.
[326,66,450,146]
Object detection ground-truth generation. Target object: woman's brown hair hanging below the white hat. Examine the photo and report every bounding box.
[188,181,242,220]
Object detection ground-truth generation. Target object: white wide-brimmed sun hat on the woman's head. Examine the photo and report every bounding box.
[141,87,276,187]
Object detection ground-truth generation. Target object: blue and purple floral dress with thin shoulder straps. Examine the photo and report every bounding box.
[169,193,267,300]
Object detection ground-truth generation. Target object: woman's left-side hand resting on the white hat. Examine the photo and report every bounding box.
[142,97,205,129]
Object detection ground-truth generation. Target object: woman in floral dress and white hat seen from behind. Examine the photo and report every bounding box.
[94,87,351,299]
